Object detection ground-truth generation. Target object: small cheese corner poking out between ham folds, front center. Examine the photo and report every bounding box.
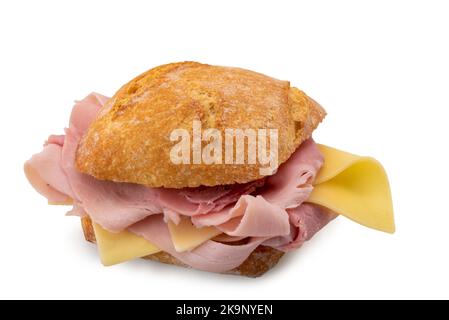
[168,218,222,252]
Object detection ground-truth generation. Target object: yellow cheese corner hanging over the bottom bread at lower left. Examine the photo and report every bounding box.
[93,223,160,266]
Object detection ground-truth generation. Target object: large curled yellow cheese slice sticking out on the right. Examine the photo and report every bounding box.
[307,145,395,233]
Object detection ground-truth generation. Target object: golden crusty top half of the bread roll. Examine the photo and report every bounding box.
[76,62,325,188]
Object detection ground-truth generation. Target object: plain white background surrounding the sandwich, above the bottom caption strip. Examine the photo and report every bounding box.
[0,0,449,299]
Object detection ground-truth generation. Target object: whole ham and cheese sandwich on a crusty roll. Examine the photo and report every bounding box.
[24,62,395,277]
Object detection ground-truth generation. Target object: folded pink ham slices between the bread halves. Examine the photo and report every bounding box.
[25,93,335,272]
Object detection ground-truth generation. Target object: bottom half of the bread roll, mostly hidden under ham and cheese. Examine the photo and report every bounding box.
[81,217,284,277]
